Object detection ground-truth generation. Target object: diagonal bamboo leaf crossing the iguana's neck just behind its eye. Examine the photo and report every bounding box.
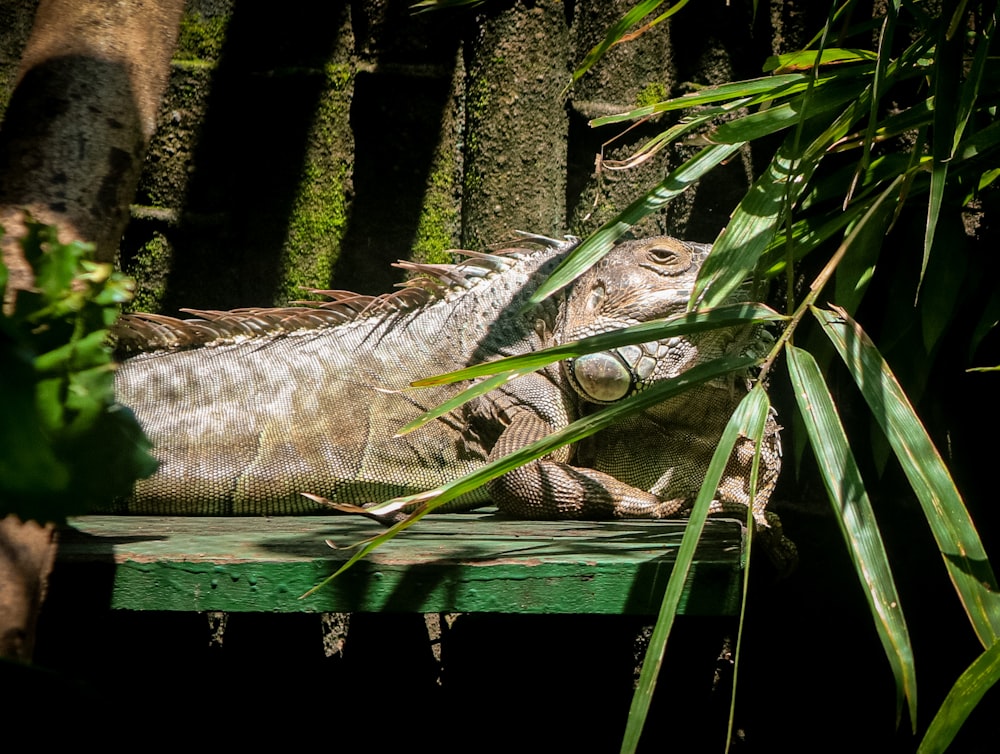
[529,144,742,305]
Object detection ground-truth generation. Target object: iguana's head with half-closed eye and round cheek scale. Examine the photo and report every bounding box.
[559,236,731,403]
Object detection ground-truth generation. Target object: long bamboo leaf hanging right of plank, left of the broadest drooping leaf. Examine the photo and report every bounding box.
[786,346,917,731]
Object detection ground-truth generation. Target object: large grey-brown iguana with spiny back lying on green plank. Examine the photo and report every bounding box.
[109,237,792,560]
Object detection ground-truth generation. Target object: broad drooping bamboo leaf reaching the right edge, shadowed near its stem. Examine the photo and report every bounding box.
[812,307,1000,647]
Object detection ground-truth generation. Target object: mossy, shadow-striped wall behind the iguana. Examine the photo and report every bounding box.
[0,0,828,313]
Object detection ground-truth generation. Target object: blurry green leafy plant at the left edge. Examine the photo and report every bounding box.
[0,221,156,522]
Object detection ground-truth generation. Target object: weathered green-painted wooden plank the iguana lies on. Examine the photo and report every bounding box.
[55,513,744,615]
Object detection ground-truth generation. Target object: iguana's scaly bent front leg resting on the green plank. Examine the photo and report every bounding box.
[488,409,688,519]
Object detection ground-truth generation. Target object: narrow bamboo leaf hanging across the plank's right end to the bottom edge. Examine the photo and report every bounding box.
[621,386,768,754]
